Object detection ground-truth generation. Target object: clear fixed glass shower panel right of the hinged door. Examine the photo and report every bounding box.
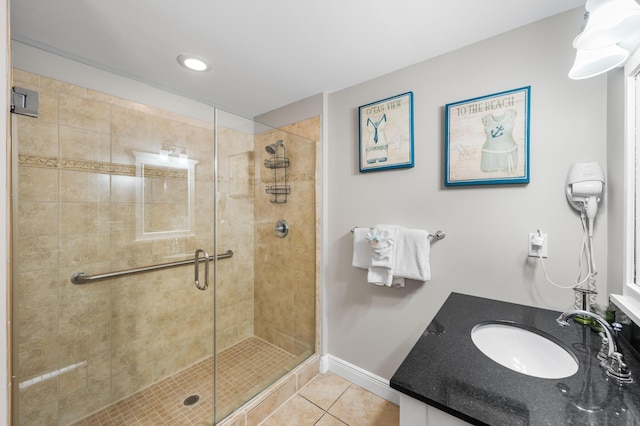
[215,110,319,421]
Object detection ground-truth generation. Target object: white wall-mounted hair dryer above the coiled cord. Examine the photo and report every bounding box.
[565,163,604,237]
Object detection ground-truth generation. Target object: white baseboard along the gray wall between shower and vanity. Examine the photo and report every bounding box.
[320,354,400,405]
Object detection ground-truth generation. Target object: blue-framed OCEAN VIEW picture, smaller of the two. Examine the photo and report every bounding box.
[358,92,414,173]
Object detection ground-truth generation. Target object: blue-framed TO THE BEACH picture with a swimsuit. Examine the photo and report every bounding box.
[445,86,531,186]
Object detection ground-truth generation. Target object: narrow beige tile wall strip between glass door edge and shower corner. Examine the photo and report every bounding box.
[216,127,255,351]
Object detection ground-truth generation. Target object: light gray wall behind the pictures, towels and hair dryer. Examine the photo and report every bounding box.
[324,9,611,378]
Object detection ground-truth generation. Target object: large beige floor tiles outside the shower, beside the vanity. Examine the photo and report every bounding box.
[260,373,400,426]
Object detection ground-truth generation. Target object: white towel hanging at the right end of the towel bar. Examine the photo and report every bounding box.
[393,228,431,281]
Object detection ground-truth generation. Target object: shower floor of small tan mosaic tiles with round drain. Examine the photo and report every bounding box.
[74,337,299,426]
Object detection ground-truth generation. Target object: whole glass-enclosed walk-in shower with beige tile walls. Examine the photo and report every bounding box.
[12,69,319,426]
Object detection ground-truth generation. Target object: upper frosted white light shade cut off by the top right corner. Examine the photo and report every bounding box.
[573,0,640,50]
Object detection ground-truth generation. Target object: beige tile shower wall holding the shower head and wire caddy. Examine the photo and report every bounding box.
[254,118,320,355]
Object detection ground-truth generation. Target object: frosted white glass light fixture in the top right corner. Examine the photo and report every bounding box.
[569,0,640,80]
